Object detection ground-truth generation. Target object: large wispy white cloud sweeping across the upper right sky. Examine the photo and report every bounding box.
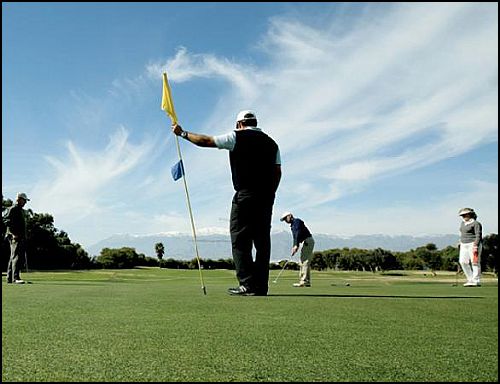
[148,3,498,210]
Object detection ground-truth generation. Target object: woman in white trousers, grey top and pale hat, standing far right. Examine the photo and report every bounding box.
[458,208,483,287]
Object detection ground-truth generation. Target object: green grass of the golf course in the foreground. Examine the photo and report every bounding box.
[2,268,498,382]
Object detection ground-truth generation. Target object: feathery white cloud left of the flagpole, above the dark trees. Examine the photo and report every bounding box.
[31,127,154,220]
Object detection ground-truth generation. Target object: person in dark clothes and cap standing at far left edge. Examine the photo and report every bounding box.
[3,193,29,284]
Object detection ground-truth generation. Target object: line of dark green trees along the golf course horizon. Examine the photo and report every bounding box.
[1,197,498,273]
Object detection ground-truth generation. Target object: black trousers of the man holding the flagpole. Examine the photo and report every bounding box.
[230,191,274,294]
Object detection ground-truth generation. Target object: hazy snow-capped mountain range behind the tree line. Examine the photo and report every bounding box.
[86,231,459,261]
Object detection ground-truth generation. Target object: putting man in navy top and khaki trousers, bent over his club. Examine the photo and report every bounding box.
[280,212,314,287]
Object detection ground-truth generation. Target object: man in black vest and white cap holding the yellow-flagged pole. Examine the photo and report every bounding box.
[172,110,281,296]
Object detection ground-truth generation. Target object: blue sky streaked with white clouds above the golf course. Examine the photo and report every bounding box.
[2,2,498,247]
